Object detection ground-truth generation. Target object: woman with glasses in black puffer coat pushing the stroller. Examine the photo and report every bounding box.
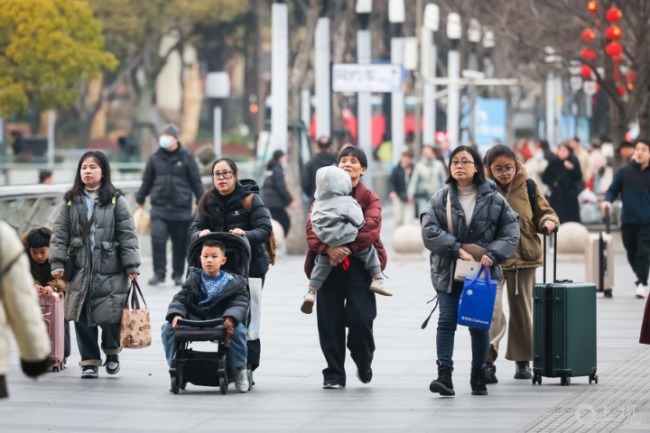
[190,158,273,370]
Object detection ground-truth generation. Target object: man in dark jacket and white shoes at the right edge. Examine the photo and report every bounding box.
[601,139,650,299]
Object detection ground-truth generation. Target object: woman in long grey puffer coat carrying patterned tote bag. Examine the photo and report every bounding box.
[50,151,140,378]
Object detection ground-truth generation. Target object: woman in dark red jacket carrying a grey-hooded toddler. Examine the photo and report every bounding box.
[305,146,386,389]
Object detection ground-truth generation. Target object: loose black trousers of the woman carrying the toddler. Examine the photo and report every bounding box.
[316,256,377,385]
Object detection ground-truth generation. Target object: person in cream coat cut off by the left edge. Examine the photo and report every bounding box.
[0,221,50,398]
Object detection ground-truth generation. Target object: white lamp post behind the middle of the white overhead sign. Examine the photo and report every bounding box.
[356,0,372,160]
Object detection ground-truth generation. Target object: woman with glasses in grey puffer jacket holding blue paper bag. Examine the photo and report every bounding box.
[422,146,519,396]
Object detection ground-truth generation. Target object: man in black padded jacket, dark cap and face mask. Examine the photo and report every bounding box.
[136,124,203,286]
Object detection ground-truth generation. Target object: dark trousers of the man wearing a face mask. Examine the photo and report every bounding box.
[151,218,190,278]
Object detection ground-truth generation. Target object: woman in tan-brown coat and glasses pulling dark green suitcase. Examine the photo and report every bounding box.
[485,145,559,383]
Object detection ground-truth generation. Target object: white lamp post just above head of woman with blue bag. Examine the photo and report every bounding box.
[447,12,462,149]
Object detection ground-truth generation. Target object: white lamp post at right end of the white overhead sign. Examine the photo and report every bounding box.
[388,0,405,164]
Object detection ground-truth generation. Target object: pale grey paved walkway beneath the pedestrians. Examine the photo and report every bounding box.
[0,221,650,433]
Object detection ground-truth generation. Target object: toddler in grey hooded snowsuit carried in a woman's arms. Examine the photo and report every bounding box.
[300,166,393,314]
